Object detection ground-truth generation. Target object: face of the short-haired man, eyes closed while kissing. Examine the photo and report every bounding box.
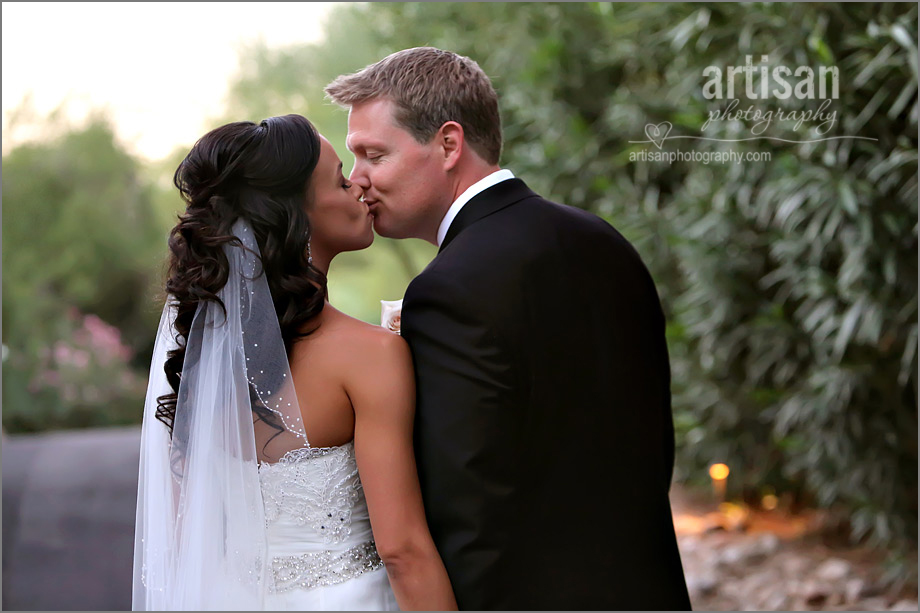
[346,99,450,243]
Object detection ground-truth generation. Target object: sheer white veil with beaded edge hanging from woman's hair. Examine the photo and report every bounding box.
[133,219,309,610]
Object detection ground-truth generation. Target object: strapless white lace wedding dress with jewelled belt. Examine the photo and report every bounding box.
[259,443,398,611]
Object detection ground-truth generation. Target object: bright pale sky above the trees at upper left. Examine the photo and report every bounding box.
[2,2,335,160]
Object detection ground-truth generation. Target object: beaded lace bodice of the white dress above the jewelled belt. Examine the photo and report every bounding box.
[259,442,364,545]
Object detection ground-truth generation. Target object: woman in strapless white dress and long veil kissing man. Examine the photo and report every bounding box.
[133,115,456,610]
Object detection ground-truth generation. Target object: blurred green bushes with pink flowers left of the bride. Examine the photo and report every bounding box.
[3,116,163,431]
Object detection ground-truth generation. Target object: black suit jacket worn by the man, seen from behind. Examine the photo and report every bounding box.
[402,179,690,610]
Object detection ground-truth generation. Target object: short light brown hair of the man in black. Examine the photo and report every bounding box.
[326,47,502,164]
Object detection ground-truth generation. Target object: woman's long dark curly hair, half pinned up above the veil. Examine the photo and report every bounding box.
[156,115,327,436]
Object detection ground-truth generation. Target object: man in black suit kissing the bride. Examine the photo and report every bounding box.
[326,47,690,610]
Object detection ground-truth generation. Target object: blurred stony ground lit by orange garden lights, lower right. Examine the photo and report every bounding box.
[671,488,917,611]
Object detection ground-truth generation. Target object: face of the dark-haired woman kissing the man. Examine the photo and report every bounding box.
[307,136,374,258]
